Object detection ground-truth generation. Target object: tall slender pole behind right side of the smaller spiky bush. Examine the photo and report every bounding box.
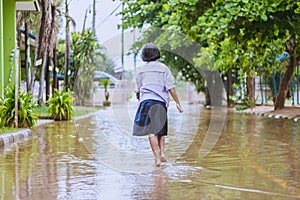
[64,0,70,91]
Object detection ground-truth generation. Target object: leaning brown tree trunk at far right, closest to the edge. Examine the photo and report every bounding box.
[274,40,297,110]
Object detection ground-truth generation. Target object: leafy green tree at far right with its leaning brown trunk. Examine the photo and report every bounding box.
[197,0,300,109]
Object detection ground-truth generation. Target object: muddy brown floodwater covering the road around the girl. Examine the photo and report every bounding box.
[0,104,300,200]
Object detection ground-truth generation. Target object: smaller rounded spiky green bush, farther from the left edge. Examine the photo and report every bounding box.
[47,89,74,120]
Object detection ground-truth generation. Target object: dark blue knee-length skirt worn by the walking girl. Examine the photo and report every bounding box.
[133,99,168,136]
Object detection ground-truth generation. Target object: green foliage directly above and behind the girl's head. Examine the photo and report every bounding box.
[121,0,209,91]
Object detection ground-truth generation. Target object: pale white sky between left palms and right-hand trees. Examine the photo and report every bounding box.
[68,0,143,70]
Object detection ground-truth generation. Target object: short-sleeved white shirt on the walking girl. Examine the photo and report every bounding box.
[136,61,175,107]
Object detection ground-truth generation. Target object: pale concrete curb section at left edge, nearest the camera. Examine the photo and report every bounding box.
[0,129,32,147]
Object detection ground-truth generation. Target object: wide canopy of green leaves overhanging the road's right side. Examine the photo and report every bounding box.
[121,0,300,108]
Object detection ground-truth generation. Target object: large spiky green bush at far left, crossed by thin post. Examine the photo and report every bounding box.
[0,87,38,127]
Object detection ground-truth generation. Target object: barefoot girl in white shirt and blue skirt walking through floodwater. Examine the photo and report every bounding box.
[133,43,183,167]
